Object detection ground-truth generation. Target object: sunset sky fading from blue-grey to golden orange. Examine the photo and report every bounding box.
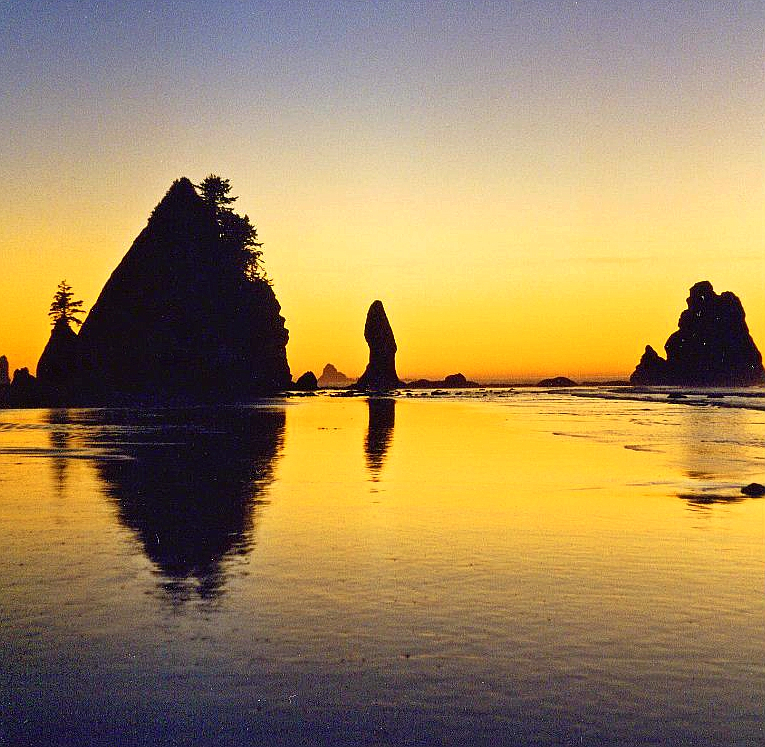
[0,0,765,379]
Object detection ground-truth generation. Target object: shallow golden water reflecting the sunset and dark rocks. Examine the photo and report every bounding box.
[0,390,765,745]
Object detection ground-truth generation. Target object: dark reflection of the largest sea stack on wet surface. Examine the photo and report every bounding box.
[83,408,285,601]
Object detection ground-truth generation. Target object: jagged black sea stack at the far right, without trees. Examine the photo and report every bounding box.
[630,281,765,386]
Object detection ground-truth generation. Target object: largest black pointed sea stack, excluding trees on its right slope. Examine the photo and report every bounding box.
[76,178,291,403]
